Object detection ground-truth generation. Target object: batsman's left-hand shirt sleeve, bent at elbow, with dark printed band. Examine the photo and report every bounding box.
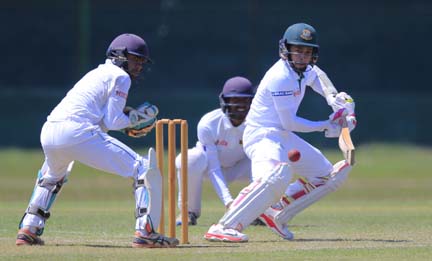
[269,75,327,132]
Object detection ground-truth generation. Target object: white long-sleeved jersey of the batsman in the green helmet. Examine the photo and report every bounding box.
[246,59,330,132]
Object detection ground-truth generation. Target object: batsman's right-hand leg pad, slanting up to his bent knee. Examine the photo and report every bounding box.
[275,160,352,224]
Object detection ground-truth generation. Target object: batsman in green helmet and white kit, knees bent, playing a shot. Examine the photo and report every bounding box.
[204,23,356,242]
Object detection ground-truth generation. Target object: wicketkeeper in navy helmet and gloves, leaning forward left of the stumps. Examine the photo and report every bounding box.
[16,34,179,248]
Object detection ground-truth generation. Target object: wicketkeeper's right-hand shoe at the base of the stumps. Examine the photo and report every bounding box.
[132,231,179,248]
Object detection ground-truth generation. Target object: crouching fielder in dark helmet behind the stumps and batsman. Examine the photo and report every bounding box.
[176,76,254,225]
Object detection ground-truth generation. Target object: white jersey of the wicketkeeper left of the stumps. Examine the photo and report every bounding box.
[48,59,131,130]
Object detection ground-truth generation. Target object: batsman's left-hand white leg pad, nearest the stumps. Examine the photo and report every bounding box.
[219,163,291,231]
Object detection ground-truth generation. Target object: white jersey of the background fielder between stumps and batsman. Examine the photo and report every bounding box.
[198,109,246,168]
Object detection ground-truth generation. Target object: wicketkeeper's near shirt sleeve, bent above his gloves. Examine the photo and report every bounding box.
[103,75,131,130]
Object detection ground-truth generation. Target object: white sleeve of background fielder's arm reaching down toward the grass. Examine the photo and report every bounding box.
[198,122,232,206]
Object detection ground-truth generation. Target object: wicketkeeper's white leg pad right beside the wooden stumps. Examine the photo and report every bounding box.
[135,148,162,231]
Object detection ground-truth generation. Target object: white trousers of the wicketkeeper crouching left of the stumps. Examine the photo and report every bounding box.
[41,122,147,181]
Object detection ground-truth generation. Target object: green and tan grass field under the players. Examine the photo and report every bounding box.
[0,144,432,260]
